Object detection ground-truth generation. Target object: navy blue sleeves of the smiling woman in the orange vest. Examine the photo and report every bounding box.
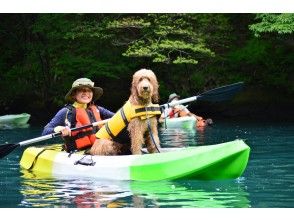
[42,106,114,135]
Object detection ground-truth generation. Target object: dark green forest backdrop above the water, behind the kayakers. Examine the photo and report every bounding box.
[0,13,294,123]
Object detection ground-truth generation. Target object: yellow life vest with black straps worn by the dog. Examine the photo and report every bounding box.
[96,101,161,139]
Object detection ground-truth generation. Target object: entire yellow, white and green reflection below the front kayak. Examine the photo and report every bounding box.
[20,171,250,208]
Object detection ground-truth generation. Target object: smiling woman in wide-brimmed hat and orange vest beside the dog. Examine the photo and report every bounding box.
[42,78,114,152]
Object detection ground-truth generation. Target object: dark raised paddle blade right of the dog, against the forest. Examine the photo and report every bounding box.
[197,82,244,102]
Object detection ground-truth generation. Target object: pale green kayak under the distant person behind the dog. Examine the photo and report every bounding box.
[162,116,196,129]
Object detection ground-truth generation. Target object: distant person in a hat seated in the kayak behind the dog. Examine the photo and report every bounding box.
[159,93,213,127]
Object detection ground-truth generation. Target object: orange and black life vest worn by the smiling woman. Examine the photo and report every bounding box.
[65,105,101,152]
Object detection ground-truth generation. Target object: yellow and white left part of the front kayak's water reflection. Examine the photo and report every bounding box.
[20,171,130,208]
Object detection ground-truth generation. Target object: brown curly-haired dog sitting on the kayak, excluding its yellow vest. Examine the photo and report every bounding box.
[90,69,159,155]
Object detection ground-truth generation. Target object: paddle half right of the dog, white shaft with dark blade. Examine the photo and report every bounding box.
[160,82,244,108]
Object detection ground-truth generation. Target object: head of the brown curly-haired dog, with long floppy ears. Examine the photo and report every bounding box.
[131,69,159,104]
